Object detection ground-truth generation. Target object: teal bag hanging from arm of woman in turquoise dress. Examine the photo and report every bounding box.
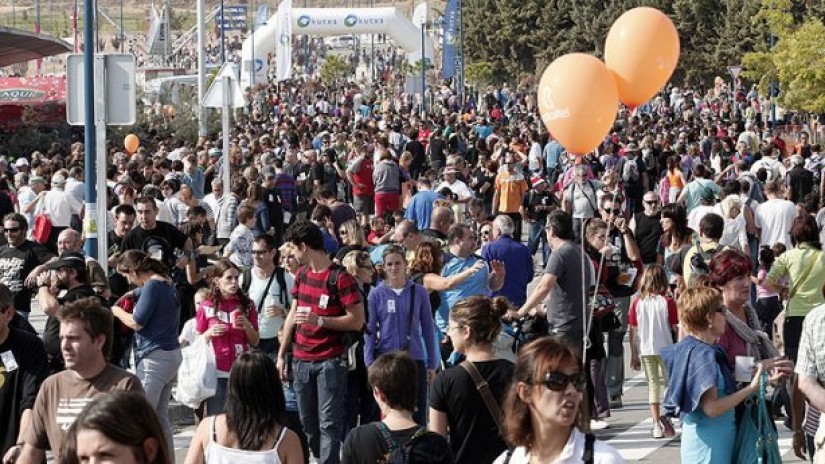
[734,372,782,464]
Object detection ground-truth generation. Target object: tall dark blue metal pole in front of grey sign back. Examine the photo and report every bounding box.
[83,0,102,258]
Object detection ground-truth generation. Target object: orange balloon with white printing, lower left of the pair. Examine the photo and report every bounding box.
[538,53,619,155]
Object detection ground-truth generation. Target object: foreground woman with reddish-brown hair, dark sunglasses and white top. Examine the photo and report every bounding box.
[495,337,624,464]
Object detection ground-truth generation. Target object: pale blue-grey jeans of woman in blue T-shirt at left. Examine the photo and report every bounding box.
[135,348,181,449]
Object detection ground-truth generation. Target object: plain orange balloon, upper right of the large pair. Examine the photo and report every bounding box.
[604,7,679,108]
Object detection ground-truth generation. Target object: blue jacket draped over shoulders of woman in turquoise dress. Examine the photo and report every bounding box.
[662,336,736,417]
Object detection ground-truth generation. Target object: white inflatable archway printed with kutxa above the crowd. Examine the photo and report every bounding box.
[241,7,434,88]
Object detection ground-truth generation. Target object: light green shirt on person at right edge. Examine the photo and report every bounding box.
[765,243,825,317]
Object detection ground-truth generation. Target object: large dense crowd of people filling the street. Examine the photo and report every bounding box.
[0,55,825,464]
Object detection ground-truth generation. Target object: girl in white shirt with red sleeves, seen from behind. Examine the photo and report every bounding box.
[627,264,679,438]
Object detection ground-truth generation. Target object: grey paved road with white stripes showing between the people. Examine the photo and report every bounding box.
[25,286,803,463]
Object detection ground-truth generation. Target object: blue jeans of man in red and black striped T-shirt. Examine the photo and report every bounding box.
[292,358,349,464]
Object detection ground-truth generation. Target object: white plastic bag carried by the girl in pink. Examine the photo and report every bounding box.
[175,336,218,409]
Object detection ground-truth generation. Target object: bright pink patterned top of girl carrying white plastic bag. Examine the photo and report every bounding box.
[195,297,258,372]
